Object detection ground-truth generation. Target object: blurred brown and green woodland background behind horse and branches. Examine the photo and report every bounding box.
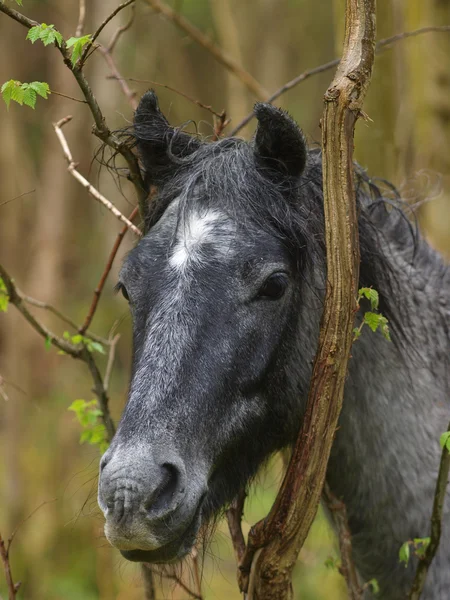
[0,0,450,600]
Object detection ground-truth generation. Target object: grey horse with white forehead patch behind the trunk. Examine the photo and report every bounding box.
[98,91,450,600]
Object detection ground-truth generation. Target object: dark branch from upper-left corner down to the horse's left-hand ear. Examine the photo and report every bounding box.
[0,2,148,223]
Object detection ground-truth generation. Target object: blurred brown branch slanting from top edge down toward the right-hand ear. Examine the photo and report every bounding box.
[142,0,269,100]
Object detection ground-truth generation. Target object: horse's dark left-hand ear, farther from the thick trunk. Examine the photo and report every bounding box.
[133,90,200,185]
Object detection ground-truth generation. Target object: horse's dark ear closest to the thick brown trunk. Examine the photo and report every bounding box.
[254,102,307,177]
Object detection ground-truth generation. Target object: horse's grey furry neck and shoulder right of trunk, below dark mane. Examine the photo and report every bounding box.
[312,237,450,600]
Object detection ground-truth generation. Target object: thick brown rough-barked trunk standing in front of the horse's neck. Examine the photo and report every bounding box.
[240,0,375,600]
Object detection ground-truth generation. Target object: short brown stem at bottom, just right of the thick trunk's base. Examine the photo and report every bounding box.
[322,483,363,600]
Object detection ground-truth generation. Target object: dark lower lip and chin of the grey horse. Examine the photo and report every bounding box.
[120,498,203,564]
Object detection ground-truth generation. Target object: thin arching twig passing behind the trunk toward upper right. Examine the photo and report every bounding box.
[230,25,450,136]
